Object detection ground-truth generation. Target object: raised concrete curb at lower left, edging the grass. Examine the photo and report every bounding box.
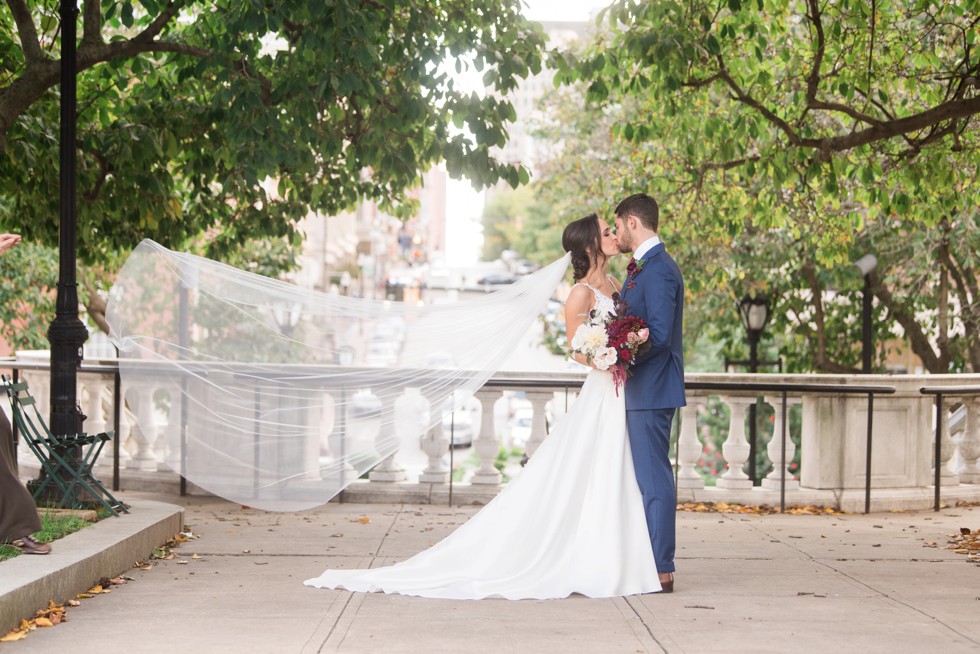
[0,500,184,634]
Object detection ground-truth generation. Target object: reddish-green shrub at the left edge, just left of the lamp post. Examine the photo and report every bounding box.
[0,241,58,351]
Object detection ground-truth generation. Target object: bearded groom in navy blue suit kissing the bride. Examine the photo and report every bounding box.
[616,193,686,593]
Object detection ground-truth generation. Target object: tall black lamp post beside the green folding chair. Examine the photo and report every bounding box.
[48,0,88,436]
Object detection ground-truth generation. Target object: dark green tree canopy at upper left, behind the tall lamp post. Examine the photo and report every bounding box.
[0,0,543,263]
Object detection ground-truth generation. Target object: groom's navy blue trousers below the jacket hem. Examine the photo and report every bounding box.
[626,409,677,572]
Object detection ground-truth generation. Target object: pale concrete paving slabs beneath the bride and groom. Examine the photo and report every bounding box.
[7,493,980,654]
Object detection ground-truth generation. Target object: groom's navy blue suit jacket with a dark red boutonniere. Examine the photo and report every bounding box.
[620,243,687,410]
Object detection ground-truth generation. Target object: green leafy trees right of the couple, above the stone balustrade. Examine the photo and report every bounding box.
[554,0,980,372]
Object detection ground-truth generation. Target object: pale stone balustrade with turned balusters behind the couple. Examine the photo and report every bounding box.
[6,361,980,511]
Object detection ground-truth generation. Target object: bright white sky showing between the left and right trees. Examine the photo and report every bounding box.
[446,0,610,266]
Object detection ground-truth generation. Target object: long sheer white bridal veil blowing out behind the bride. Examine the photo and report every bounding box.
[106,240,569,511]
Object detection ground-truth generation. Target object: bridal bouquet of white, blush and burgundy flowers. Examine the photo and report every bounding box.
[572,309,650,395]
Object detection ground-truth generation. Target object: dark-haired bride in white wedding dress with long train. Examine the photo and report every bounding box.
[304,215,661,599]
